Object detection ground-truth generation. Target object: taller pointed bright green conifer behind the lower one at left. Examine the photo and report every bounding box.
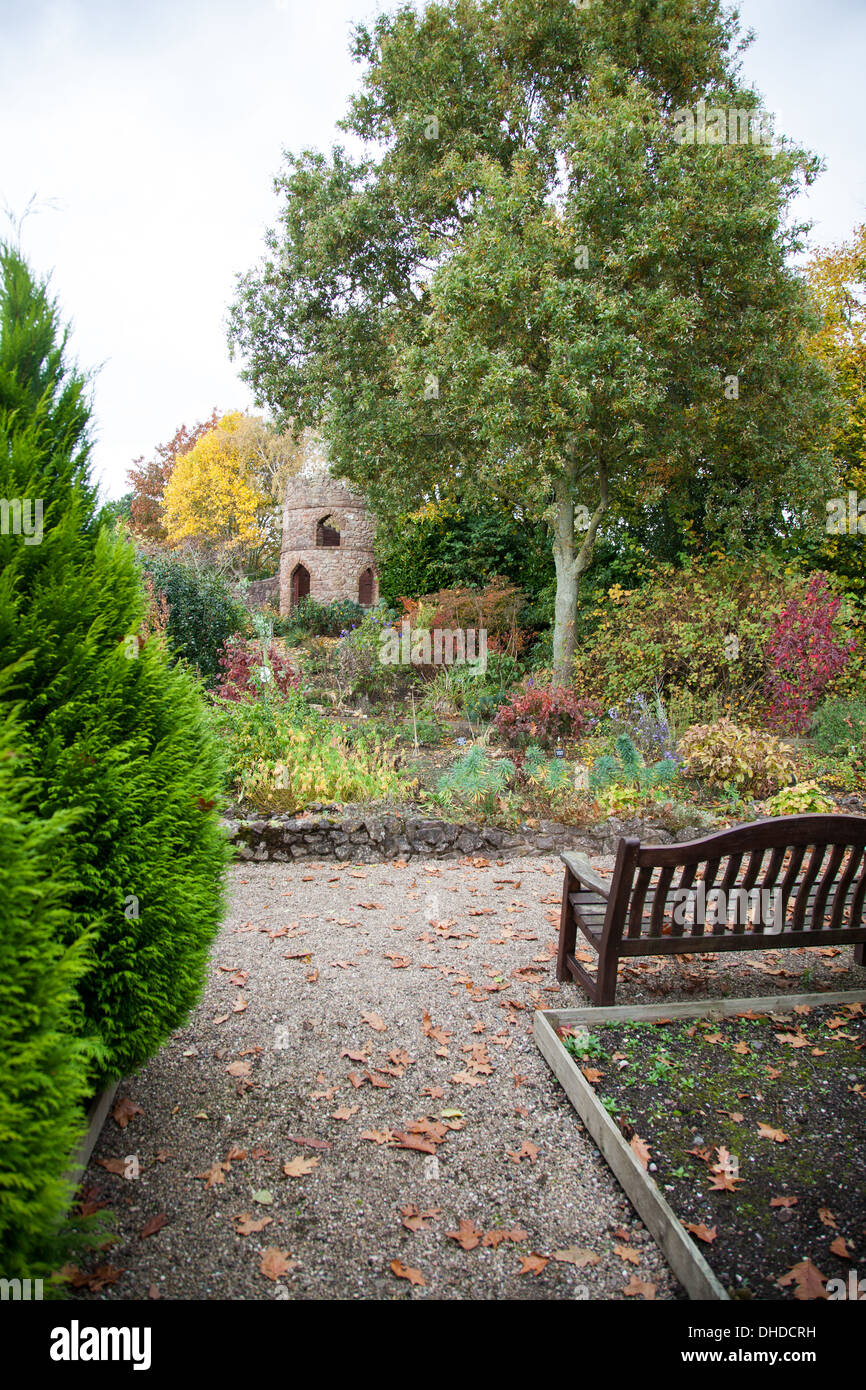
[0,252,228,1081]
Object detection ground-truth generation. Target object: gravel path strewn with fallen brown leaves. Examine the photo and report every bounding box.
[76,858,866,1300]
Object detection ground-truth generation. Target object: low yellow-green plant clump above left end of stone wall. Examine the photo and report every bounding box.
[238,726,405,812]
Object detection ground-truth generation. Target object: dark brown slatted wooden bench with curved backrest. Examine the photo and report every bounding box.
[556,816,866,1004]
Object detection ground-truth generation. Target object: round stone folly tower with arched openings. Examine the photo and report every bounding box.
[279,471,378,614]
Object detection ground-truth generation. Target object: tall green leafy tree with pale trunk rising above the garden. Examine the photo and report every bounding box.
[229,0,833,680]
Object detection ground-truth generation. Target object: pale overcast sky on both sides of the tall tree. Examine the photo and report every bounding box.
[0,0,866,496]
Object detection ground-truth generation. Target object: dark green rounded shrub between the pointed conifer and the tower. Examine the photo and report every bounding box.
[145,556,249,685]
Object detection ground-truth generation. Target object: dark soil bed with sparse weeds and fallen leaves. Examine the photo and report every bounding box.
[560,1002,866,1300]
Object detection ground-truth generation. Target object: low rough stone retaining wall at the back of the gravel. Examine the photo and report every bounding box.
[224,808,706,863]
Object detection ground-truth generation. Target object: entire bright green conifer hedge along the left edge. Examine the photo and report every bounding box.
[0,246,228,1277]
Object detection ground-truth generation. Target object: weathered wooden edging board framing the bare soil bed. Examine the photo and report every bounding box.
[532,990,866,1302]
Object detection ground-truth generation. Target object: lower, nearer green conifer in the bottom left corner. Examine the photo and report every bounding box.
[0,706,90,1279]
